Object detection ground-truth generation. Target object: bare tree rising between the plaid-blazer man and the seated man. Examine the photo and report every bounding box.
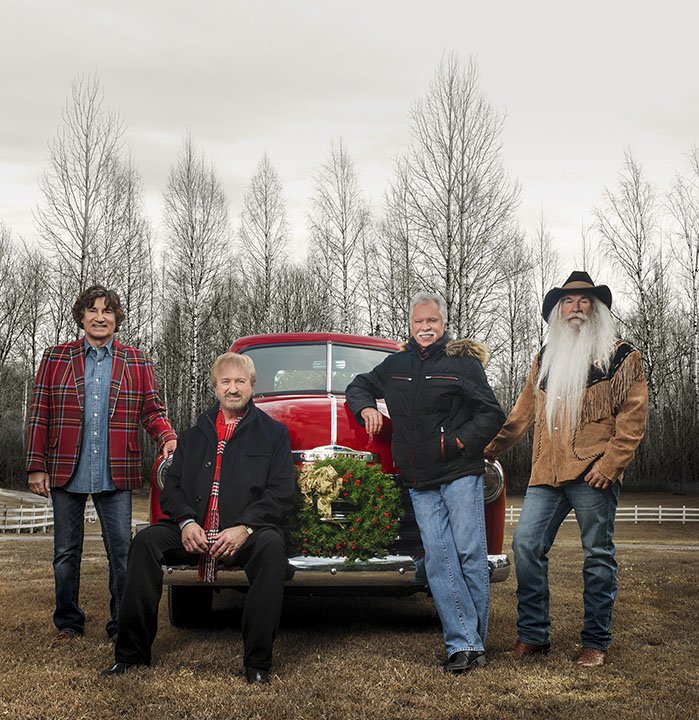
[164,136,229,424]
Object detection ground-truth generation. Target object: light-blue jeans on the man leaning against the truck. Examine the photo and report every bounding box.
[410,475,490,657]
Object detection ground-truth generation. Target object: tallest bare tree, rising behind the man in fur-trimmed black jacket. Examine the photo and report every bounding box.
[406,55,521,336]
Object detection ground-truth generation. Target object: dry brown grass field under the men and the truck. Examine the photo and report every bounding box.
[0,500,699,720]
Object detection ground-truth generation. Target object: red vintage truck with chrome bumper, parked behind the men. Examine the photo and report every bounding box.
[150,333,510,625]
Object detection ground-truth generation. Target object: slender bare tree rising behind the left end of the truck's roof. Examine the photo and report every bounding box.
[239,153,288,331]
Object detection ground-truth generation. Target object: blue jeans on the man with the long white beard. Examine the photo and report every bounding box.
[512,478,619,650]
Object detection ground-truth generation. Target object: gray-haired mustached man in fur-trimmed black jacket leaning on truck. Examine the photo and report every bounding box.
[346,293,505,673]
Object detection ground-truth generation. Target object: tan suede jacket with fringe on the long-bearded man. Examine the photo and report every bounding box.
[486,340,648,485]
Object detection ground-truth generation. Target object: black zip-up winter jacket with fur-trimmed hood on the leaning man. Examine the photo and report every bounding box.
[346,333,505,488]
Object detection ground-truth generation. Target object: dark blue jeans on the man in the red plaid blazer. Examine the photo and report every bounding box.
[51,488,131,637]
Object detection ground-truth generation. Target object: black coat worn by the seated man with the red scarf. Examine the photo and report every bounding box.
[160,402,296,529]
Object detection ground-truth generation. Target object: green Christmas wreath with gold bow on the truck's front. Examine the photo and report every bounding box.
[291,457,401,562]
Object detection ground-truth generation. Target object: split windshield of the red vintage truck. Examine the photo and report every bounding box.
[241,343,390,395]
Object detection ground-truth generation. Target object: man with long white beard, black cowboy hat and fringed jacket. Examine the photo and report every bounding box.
[486,271,648,667]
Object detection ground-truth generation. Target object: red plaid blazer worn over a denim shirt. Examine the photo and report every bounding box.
[26,338,177,490]
